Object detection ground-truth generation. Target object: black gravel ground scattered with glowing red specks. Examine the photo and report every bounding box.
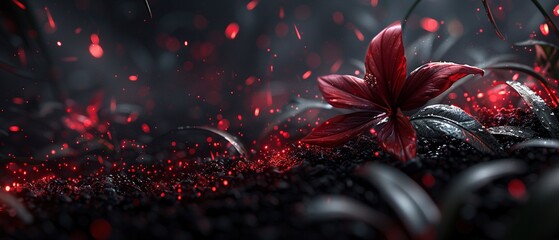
[0,110,559,239]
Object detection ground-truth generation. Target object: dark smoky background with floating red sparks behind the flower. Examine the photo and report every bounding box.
[0,0,558,150]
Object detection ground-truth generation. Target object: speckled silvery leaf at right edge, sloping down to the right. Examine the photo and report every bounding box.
[507,81,559,138]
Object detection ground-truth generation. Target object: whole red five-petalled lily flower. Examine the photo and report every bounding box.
[302,22,483,161]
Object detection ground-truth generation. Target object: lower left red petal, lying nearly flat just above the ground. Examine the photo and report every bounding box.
[301,112,386,147]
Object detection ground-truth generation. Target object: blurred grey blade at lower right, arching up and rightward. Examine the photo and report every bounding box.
[437,159,527,239]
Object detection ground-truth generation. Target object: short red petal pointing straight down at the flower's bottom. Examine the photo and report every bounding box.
[375,110,416,162]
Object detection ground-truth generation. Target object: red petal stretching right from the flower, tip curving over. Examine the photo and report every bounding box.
[398,62,483,110]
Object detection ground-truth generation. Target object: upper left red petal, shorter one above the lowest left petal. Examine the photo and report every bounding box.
[318,75,385,110]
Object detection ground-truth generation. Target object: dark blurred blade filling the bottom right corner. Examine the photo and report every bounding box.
[503,164,559,240]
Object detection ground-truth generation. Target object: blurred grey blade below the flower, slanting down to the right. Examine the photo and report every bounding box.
[356,163,440,236]
